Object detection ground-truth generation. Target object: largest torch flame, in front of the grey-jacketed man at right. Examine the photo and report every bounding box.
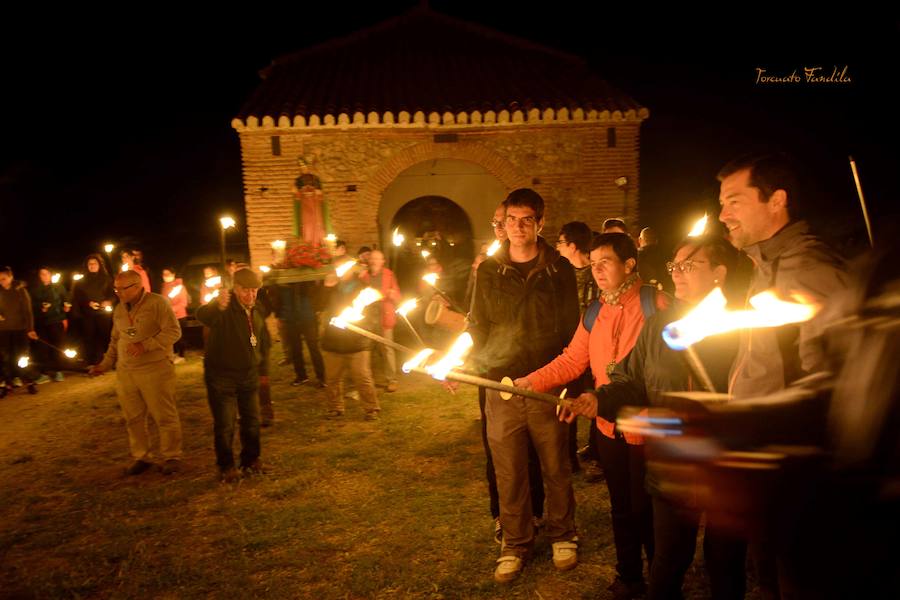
[663,288,821,350]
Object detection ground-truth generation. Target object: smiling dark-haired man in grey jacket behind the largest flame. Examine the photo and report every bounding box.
[718,154,847,398]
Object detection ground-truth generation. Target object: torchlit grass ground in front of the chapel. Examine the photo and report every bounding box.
[0,338,732,600]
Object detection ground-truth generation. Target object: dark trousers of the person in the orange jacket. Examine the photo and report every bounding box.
[597,433,653,583]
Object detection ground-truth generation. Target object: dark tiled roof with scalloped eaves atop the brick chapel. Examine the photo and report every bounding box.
[236,8,648,126]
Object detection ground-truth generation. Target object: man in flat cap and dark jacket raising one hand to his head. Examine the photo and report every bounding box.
[197,268,270,483]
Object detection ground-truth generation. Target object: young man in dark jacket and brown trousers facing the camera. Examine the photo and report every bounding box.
[469,189,578,582]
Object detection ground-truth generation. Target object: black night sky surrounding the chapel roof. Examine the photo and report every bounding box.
[0,1,900,282]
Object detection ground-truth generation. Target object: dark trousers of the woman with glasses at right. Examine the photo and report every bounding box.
[647,496,747,600]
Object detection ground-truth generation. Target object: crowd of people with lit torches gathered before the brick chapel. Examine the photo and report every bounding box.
[0,154,884,598]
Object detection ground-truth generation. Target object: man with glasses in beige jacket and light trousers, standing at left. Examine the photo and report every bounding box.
[88,271,181,475]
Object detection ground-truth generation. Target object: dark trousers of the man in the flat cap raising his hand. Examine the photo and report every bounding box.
[204,371,260,470]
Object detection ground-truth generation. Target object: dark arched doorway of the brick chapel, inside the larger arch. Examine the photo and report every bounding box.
[390,196,474,304]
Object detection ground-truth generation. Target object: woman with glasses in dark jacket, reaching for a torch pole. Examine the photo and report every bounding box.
[560,236,752,598]
